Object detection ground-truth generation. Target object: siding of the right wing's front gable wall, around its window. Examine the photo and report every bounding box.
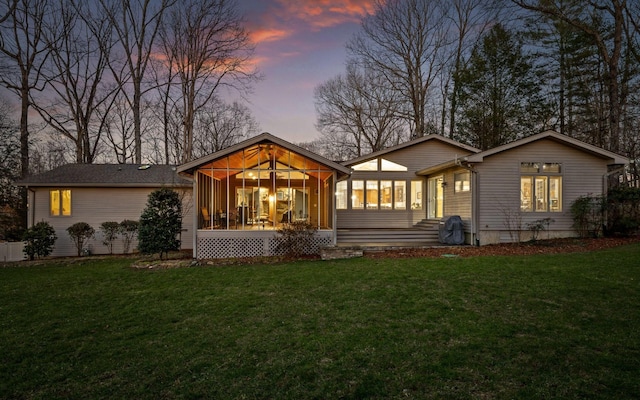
[476,140,607,244]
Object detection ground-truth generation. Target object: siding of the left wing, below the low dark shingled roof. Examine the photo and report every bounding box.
[29,188,193,257]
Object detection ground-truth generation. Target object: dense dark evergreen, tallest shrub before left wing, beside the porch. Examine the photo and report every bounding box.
[138,188,182,259]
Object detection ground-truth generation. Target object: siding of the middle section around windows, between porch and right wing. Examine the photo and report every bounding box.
[337,140,476,229]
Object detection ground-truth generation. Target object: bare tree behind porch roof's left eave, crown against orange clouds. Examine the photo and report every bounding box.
[160,0,258,162]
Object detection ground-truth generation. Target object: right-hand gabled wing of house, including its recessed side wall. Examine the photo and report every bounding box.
[417,131,628,245]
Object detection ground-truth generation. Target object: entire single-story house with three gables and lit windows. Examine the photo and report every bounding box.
[20,131,628,258]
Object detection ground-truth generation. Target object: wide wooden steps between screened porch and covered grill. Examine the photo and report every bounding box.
[337,220,442,247]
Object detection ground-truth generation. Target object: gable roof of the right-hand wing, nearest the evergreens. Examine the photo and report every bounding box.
[466,130,629,165]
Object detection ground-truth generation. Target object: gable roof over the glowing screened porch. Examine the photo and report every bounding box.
[178,132,351,175]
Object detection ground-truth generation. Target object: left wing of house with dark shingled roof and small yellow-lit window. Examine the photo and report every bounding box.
[17,164,193,256]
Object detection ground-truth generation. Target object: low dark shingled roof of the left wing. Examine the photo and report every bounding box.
[16,164,192,187]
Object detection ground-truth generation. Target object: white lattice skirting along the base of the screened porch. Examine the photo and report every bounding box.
[196,231,333,259]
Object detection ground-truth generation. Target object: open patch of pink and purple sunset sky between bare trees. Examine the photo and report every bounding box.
[238,0,374,143]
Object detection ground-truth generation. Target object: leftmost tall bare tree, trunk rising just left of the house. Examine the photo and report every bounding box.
[0,0,49,177]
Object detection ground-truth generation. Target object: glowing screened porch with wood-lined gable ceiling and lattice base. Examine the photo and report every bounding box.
[178,133,350,259]
